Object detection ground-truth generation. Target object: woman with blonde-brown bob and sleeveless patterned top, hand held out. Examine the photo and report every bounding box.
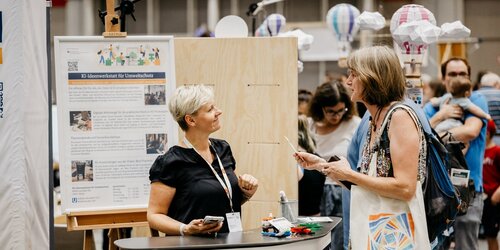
[295,46,426,249]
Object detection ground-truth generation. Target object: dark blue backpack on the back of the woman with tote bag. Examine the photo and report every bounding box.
[390,104,461,242]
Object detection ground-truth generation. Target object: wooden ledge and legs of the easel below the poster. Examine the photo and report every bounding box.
[66,208,148,250]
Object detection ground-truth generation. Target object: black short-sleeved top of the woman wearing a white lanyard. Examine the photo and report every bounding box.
[149,139,242,233]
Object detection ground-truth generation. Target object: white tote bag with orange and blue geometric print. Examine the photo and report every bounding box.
[349,104,431,249]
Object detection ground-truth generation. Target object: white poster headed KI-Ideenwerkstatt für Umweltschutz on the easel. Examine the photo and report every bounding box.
[54,36,178,213]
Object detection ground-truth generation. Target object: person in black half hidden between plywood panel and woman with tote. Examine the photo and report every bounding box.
[297,115,325,216]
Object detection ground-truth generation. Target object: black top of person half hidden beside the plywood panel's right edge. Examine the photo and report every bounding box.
[299,169,325,216]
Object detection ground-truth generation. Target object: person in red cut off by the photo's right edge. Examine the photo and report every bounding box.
[481,120,500,250]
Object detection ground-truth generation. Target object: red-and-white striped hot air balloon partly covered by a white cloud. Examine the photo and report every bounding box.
[391,4,436,54]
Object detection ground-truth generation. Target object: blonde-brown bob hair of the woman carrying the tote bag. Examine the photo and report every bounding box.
[347,46,405,107]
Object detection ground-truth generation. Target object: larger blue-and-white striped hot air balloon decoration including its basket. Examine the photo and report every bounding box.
[326,3,359,67]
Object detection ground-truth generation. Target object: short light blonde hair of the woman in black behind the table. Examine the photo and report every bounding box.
[168,84,214,131]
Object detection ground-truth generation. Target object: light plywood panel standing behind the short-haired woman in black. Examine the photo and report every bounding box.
[174,38,298,229]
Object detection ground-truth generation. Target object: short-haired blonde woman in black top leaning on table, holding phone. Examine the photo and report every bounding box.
[147,85,258,235]
